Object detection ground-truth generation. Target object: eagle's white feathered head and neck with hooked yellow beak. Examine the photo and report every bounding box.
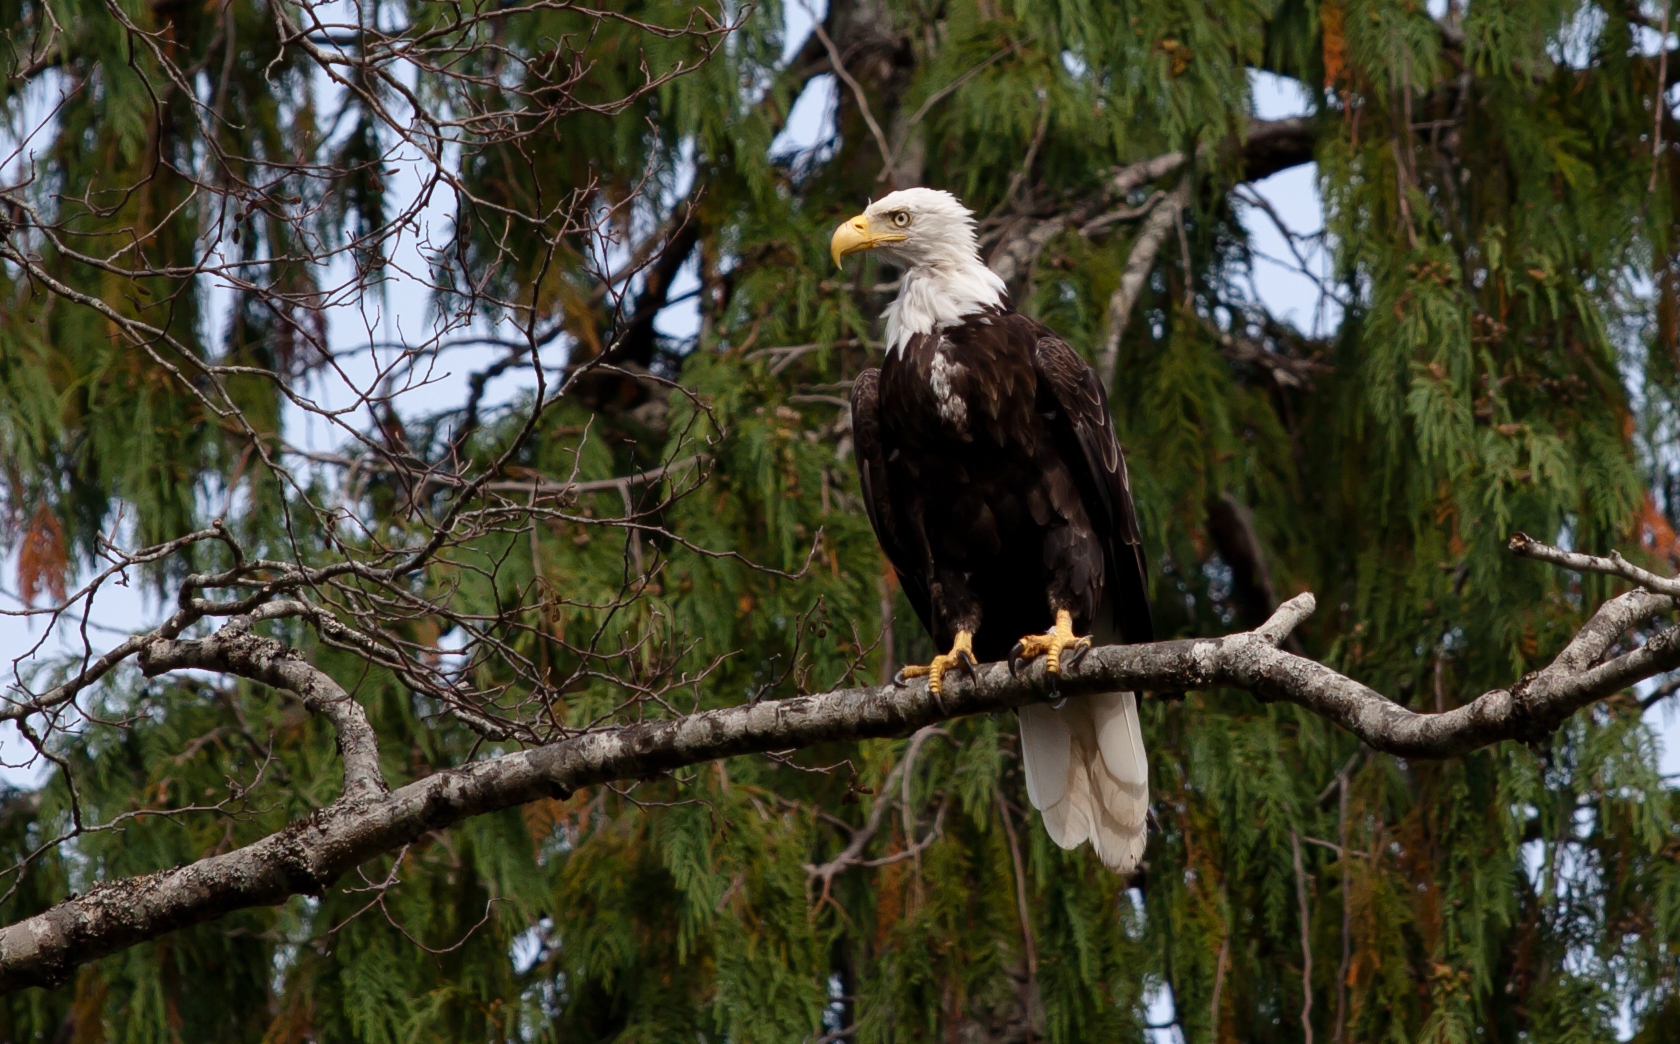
[830,188,1008,359]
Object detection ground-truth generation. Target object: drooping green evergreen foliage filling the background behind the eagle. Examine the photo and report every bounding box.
[0,0,1680,1044]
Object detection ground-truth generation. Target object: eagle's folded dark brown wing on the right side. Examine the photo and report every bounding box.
[1033,326,1154,642]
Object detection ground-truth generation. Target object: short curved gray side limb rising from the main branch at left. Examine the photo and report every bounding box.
[139,617,386,804]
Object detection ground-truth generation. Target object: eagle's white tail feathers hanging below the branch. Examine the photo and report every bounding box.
[1020,693,1149,874]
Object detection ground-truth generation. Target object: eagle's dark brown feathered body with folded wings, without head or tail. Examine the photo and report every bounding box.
[852,308,1151,661]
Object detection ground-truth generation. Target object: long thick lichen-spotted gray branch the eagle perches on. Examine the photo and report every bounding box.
[0,535,1680,992]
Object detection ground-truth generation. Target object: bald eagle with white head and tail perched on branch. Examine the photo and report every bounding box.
[832,188,1152,873]
